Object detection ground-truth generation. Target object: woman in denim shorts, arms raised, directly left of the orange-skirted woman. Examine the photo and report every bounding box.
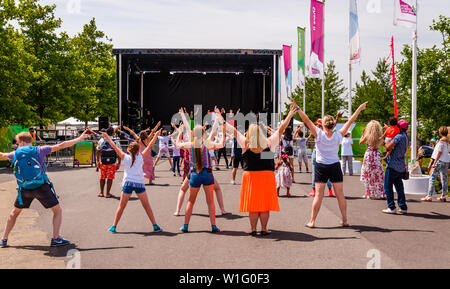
[177,108,226,233]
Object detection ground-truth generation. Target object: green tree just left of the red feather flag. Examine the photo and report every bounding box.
[352,59,394,123]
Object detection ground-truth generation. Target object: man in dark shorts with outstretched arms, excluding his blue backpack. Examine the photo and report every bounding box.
[0,132,86,247]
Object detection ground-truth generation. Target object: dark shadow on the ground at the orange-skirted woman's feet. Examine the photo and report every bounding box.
[218,230,359,242]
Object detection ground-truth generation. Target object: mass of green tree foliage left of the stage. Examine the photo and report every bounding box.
[0,0,117,127]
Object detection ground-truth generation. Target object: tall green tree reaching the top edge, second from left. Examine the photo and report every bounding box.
[17,0,71,128]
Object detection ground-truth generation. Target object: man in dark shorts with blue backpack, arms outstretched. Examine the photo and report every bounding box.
[0,131,86,247]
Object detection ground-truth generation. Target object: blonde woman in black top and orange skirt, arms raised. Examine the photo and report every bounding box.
[227,102,298,236]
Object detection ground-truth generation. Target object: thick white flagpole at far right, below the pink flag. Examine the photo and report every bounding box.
[411,29,417,160]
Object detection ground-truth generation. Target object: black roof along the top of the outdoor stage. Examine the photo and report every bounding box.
[113,48,282,73]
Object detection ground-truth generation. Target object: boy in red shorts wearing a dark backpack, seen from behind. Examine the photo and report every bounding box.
[97,127,121,198]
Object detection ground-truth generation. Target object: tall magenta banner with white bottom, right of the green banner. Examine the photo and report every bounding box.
[309,0,324,78]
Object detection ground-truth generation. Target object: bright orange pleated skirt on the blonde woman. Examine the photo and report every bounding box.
[239,171,280,213]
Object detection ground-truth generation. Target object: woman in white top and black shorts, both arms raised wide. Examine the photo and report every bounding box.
[298,102,367,228]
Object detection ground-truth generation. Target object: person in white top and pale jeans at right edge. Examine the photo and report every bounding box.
[421,126,450,202]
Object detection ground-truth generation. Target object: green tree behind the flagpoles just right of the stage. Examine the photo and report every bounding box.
[285,60,346,120]
